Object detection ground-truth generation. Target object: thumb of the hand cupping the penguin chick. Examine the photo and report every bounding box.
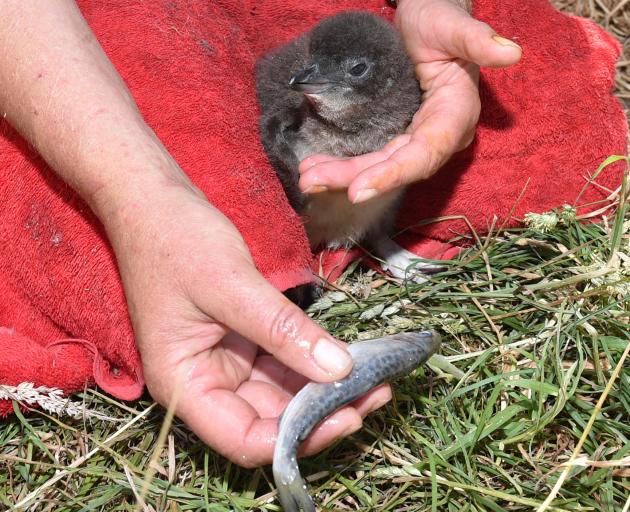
[436,9,522,68]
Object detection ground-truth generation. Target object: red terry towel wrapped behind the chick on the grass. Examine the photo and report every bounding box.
[0,0,627,415]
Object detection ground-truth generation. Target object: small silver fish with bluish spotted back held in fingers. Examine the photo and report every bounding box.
[273,331,440,512]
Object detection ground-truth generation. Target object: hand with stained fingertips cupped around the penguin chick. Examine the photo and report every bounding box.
[300,0,521,203]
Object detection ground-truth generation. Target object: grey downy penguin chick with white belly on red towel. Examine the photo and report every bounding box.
[257,11,440,296]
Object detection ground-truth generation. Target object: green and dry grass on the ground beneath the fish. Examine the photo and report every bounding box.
[0,158,630,512]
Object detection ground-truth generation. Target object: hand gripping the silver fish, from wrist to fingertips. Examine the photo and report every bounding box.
[107,185,391,467]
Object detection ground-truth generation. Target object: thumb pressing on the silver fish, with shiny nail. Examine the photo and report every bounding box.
[207,265,353,382]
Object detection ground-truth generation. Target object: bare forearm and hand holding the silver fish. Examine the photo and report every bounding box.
[0,0,391,466]
